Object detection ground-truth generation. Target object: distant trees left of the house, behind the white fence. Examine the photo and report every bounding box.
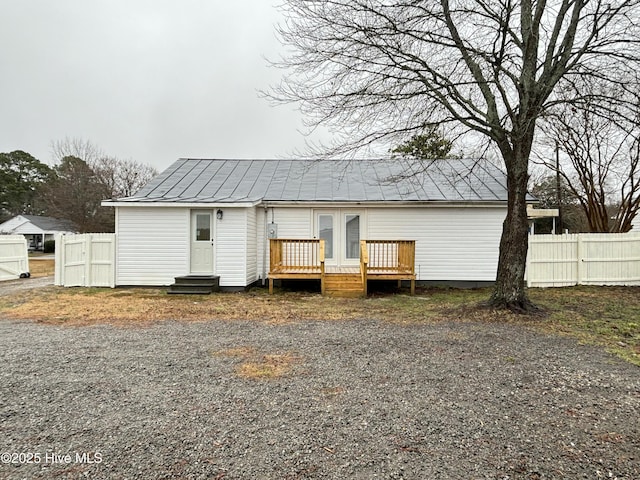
[0,138,157,232]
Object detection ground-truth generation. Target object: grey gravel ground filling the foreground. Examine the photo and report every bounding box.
[0,320,640,480]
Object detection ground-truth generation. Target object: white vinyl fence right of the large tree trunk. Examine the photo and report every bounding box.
[527,233,640,287]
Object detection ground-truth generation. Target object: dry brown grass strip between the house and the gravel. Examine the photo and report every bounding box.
[0,287,640,366]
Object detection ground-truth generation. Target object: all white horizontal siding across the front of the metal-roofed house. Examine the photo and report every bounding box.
[116,205,506,287]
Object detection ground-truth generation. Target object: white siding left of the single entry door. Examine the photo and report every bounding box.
[116,207,188,286]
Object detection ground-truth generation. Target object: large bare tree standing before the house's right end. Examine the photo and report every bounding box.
[270,0,640,310]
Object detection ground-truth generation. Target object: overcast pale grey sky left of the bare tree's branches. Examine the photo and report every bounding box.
[0,0,324,170]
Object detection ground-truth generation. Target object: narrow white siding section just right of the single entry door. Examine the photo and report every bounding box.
[215,208,249,287]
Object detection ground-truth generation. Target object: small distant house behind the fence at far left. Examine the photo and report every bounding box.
[0,215,77,250]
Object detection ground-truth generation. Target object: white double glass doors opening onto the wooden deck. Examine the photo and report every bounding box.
[315,209,363,265]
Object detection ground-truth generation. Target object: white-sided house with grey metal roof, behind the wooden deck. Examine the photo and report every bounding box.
[103,159,507,287]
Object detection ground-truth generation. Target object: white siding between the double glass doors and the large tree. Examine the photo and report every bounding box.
[365,207,506,281]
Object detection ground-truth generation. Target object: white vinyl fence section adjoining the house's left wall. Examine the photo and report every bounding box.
[55,233,116,288]
